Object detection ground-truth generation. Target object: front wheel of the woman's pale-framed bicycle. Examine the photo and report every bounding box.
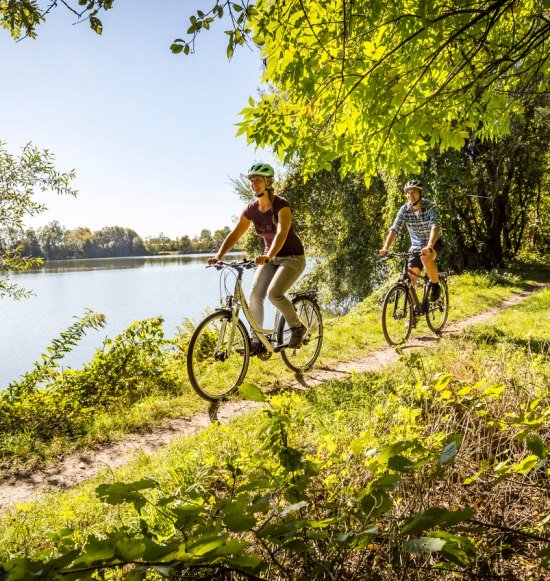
[187,311,250,401]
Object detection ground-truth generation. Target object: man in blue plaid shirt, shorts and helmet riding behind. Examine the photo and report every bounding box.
[378,180,443,301]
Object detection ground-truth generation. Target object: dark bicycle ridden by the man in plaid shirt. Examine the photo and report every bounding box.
[382,250,449,346]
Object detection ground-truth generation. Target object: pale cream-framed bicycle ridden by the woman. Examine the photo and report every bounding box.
[187,260,323,401]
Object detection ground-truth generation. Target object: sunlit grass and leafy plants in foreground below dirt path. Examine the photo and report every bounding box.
[0,280,550,580]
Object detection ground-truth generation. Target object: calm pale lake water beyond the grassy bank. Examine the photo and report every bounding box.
[0,255,274,389]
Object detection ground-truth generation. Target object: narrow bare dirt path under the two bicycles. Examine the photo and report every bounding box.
[0,285,543,509]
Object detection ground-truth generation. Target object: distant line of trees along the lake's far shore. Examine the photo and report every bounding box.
[0,220,234,260]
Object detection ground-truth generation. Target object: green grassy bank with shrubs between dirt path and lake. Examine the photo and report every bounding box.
[0,266,548,467]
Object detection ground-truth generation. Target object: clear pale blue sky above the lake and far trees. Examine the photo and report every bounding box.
[0,0,273,237]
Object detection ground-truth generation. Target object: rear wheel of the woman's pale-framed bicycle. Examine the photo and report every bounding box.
[277,297,323,372]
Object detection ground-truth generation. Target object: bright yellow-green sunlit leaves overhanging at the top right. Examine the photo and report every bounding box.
[201,0,547,175]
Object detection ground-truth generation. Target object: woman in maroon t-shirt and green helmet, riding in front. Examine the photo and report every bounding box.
[208,163,307,355]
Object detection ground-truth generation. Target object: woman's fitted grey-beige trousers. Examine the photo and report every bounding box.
[250,254,306,336]
